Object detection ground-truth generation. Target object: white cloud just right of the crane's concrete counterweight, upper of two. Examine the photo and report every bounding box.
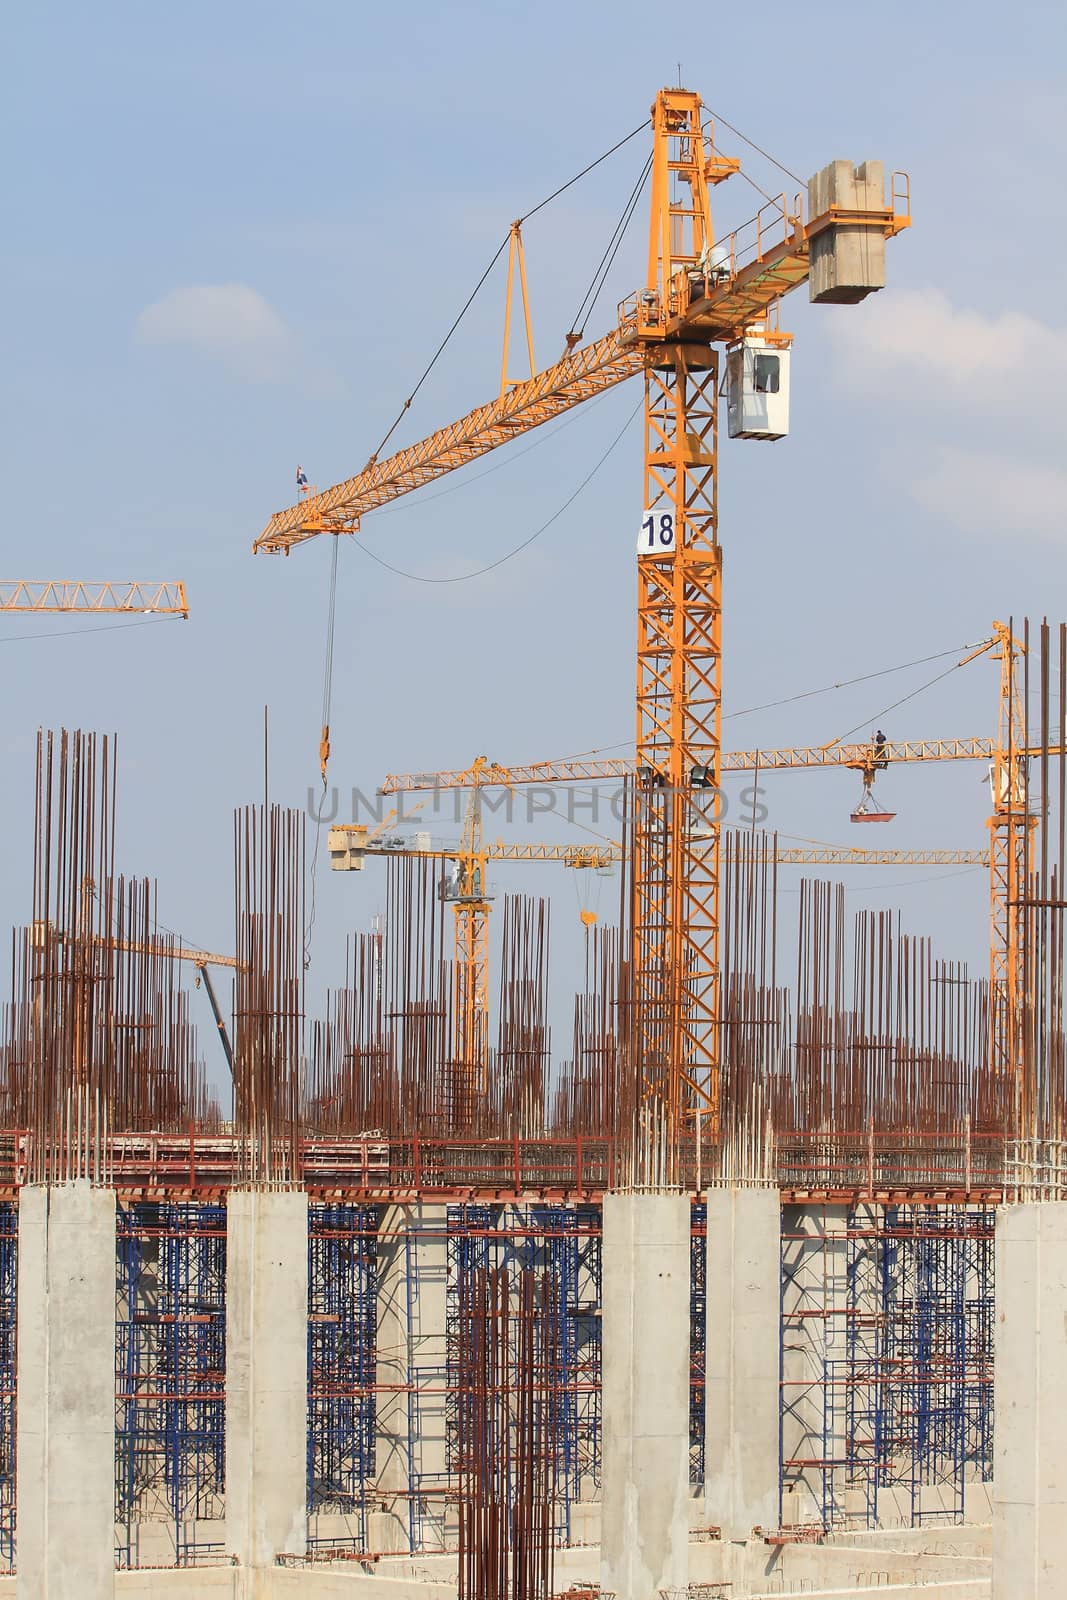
[829,290,1067,411]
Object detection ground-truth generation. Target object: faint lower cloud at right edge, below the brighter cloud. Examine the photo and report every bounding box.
[912,450,1067,542]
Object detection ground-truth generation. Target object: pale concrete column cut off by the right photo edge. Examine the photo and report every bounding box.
[993,1200,1067,1600]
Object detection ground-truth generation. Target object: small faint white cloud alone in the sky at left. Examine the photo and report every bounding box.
[136,283,291,378]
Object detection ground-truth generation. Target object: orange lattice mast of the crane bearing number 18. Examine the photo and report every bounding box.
[630,90,726,1181]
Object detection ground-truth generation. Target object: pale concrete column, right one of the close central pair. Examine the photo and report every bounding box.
[704,1189,781,1541]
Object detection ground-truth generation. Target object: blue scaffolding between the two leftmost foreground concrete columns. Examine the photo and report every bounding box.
[115,1200,226,1566]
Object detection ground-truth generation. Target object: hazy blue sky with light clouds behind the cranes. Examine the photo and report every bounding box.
[0,0,1067,1094]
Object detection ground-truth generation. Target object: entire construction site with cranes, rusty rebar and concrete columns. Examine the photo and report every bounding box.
[0,34,1067,1600]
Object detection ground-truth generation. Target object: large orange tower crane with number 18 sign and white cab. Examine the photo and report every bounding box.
[253,88,910,1164]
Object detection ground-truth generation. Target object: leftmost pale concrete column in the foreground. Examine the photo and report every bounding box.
[16,1182,115,1600]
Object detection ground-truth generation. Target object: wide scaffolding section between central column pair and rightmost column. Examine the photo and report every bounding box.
[781,1203,993,1528]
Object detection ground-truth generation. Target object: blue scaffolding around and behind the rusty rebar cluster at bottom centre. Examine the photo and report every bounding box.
[446,1205,601,1544]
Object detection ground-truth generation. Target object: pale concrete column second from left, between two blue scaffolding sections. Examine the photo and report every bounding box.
[226,1189,307,1595]
